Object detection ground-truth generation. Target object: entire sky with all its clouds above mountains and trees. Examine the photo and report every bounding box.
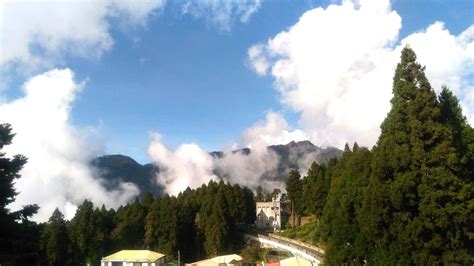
[0,0,474,220]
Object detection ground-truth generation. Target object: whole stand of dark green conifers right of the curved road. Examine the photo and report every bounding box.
[280,47,474,265]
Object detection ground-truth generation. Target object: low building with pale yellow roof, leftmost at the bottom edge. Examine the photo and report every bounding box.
[101,250,165,266]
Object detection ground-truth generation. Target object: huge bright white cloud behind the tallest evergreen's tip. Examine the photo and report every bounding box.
[248,0,474,147]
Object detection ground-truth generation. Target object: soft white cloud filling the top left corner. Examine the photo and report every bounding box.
[0,0,165,69]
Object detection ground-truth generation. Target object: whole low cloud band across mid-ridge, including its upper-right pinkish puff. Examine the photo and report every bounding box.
[148,112,306,195]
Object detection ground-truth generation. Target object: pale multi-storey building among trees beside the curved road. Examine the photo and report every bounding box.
[256,194,288,231]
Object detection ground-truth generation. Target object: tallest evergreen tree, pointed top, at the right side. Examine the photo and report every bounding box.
[361,47,474,265]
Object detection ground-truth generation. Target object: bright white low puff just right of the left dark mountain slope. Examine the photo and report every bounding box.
[148,133,217,195]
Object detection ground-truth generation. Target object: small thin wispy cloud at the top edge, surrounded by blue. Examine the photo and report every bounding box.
[181,0,261,31]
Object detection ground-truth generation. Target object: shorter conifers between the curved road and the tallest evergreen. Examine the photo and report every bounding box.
[321,144,371,265]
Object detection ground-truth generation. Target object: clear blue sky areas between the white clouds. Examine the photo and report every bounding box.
[3,0,474,162]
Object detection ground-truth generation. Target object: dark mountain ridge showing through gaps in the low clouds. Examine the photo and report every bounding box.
[91,141,342,195]
